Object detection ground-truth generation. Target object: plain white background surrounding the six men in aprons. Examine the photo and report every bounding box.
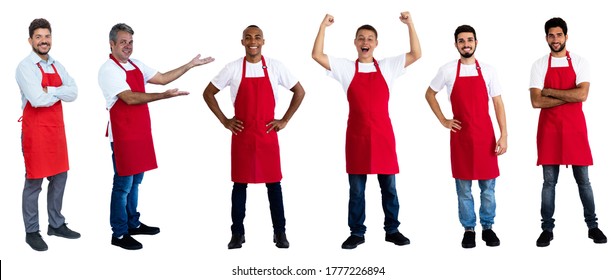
[0,0,615,280]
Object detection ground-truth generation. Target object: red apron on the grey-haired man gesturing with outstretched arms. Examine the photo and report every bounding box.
[109,55,158,176]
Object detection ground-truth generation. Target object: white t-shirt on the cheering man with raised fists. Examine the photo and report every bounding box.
[327,54,406,94]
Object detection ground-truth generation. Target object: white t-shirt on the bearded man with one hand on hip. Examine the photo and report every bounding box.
[429,59,502,100]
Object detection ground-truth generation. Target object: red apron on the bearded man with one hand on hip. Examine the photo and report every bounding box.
[451,60,500,180]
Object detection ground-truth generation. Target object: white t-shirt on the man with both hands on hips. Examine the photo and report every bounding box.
[211,56,299,104]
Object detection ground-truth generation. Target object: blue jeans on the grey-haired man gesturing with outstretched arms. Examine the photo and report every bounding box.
[110,143,143,237]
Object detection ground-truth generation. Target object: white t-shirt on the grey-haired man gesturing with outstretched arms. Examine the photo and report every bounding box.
[98,59,158,142]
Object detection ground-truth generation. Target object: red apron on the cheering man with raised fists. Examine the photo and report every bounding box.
[346,59,399,174]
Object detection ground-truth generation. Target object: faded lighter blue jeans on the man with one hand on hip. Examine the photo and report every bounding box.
[455,179,495,230]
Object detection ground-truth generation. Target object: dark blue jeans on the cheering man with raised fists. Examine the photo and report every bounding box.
[348,174,400,237]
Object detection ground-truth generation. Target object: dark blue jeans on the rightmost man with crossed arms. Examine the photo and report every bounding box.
[540,165,598,231]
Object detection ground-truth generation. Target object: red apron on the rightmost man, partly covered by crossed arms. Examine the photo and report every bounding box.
[536,51,594,166]
